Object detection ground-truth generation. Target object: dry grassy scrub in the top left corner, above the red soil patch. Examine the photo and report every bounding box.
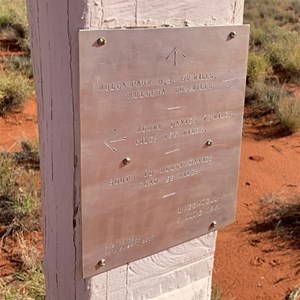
[0,0,33,116]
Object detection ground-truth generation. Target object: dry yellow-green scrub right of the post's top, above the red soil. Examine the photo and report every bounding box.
[244,0,300,133]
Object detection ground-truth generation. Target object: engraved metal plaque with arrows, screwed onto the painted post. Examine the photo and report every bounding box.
[79,26,249,278]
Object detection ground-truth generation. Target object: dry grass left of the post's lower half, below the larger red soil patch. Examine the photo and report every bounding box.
[0,141,45,300]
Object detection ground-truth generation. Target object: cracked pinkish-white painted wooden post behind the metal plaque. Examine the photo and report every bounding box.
[27,0,244,300]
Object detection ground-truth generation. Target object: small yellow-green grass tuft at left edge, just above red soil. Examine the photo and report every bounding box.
[0,72,32,116]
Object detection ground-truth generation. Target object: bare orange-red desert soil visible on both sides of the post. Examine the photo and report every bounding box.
[0,99,300,300]
